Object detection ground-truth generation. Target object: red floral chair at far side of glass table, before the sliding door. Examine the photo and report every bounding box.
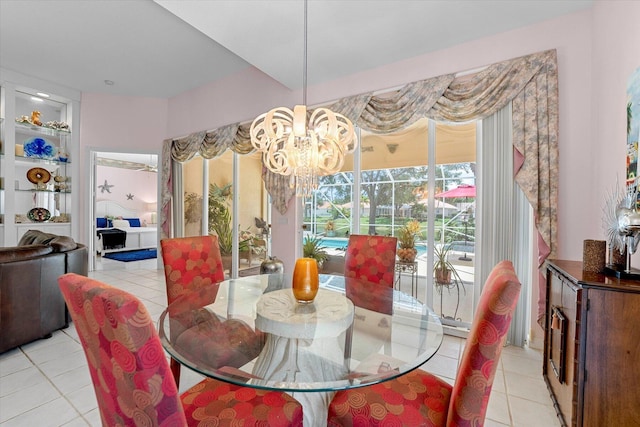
[344,234,398,314]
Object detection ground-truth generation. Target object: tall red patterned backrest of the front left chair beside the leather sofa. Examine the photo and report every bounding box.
[58,273,187,426]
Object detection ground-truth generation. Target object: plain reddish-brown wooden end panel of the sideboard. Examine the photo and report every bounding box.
[581,289,640,427]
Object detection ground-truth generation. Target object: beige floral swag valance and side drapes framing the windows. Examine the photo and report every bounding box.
[163,50,558,314]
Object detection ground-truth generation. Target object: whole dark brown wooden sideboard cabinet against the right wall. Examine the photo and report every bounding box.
[542,260,640,427]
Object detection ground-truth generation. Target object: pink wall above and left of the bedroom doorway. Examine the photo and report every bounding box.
[79,93,169,242]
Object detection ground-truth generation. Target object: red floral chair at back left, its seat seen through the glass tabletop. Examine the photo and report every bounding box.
[160,235,264,386]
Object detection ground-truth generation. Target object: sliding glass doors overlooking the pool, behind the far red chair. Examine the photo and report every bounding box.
[305,119,476,328]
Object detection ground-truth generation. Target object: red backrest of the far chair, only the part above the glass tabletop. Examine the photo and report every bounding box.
[344,234,398,287]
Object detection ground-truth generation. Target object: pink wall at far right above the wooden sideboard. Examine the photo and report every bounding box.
[592,1,640,268]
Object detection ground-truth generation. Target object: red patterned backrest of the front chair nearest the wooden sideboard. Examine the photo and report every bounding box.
[447,261,521,426]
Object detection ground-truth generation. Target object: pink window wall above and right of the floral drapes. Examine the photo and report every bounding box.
[158,10,596,267]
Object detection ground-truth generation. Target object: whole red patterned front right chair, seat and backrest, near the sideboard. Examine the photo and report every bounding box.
[327,261,521,427]
